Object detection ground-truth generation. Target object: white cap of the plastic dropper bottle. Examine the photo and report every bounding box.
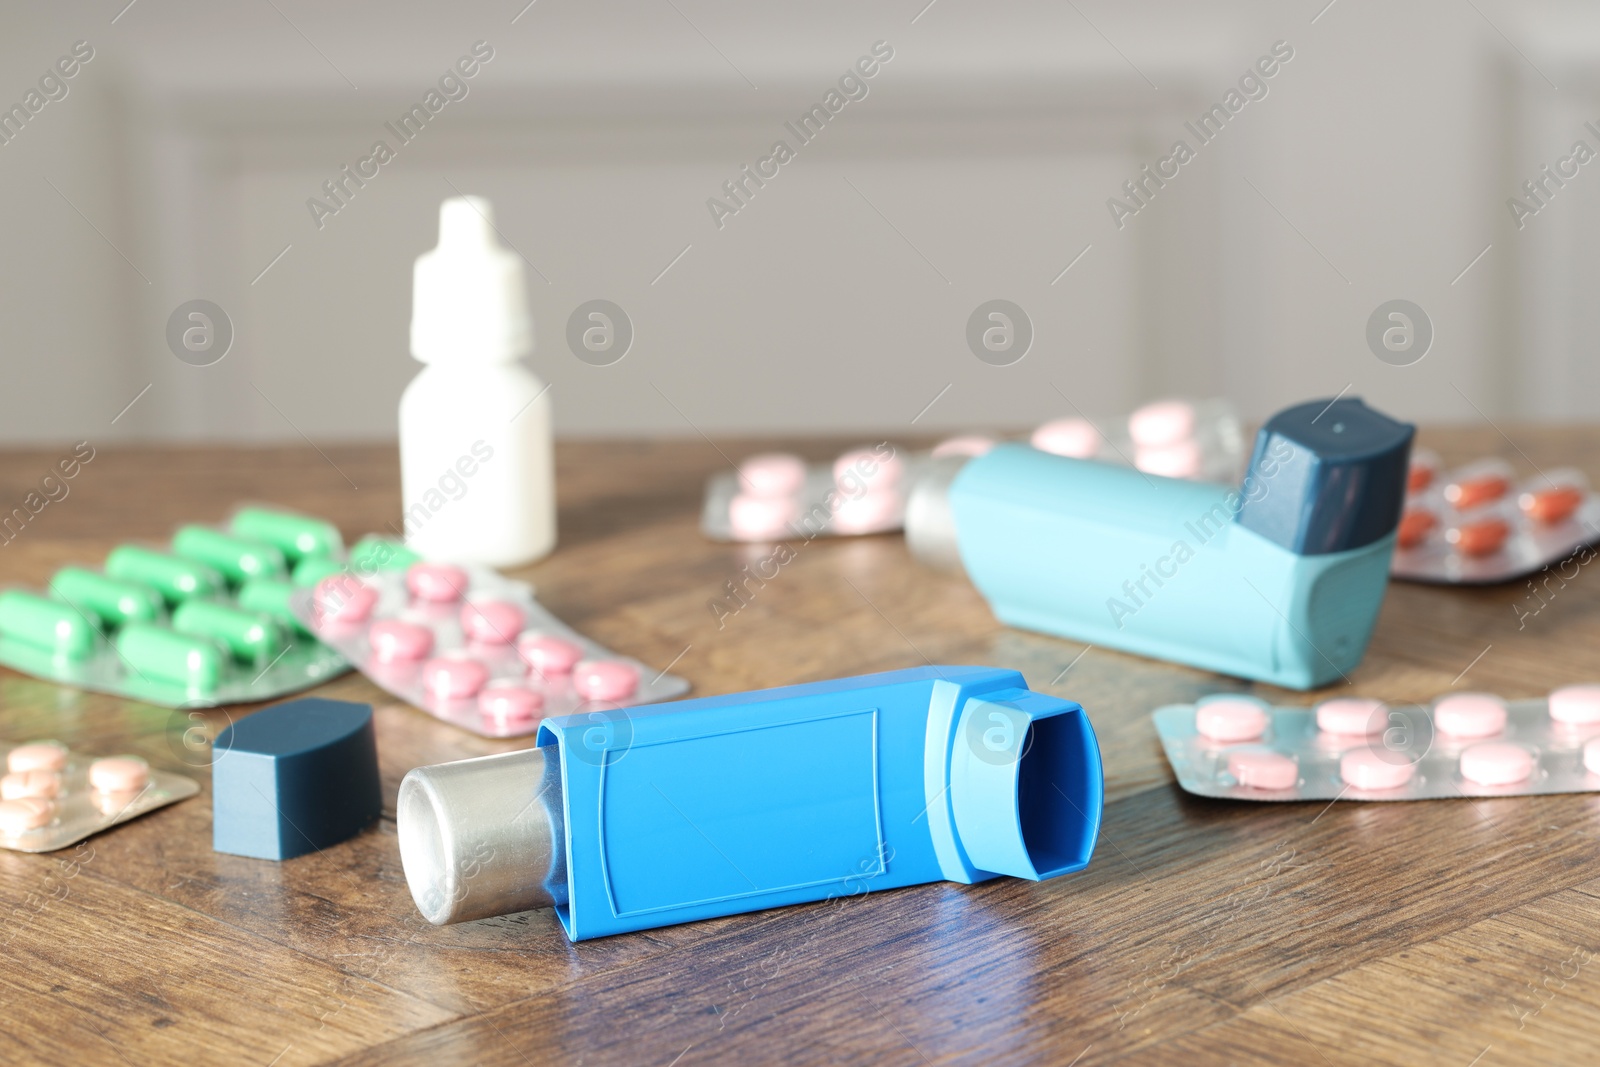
[411,197,533,363]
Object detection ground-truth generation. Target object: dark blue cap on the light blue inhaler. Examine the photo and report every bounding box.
[1238,397,1416,555]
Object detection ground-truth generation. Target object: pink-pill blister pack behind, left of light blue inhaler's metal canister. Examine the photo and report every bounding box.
[701,442,925,541]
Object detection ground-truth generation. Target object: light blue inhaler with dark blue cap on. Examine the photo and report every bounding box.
[906,398,1414,689]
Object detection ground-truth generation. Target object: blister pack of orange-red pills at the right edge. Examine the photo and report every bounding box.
[1389,448,1600,585]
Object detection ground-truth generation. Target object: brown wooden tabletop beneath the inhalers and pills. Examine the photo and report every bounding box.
[0,429,1600,1067]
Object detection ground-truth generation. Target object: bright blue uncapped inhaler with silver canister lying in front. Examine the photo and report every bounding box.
[398,667,1102,941]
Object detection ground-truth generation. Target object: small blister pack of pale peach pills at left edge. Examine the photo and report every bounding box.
[0,741,200,853]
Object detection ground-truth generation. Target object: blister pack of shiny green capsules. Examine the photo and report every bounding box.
[0,507,416,707]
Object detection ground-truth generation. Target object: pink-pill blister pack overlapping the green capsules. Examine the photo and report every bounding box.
[291,561,690,737]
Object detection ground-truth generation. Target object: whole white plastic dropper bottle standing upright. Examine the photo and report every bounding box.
[400,197,555,566]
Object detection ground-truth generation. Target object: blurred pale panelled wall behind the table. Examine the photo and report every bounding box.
[0,0,1600,442]
